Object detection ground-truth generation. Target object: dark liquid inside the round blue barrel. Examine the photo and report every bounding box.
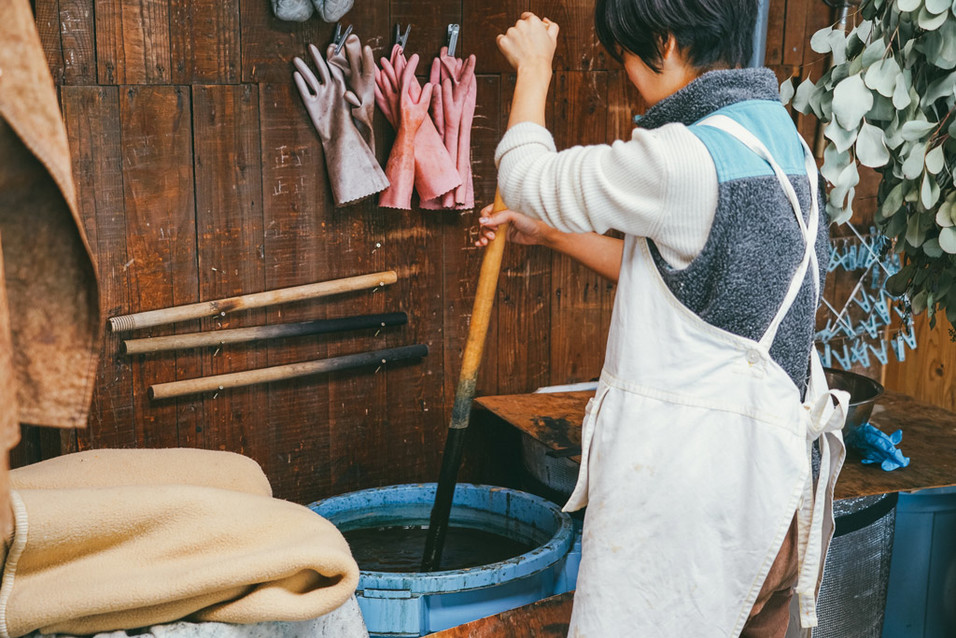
[343,526,534,572]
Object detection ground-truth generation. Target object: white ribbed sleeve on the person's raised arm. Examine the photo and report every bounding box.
[495,122,717,268]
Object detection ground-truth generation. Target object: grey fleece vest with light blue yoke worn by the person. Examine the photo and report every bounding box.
[638,69,829,394]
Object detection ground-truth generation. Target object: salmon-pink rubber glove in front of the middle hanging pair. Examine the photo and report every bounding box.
[378,54,433,210]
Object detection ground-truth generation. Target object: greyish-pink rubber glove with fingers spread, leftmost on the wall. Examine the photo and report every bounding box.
[292,44,388,206]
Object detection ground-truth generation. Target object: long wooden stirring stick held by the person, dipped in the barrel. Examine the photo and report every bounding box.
[422,192,508,572]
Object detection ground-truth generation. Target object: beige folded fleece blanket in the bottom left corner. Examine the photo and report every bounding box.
[0,450,358,638]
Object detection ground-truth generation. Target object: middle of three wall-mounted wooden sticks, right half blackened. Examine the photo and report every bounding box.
[123,312,408,354]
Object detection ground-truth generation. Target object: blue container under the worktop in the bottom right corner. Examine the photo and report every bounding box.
[883,487,956,638]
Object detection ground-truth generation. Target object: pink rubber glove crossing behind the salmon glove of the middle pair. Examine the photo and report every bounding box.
[375,45,461,200]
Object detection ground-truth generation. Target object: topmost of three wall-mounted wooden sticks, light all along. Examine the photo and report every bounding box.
[110,270,398,332]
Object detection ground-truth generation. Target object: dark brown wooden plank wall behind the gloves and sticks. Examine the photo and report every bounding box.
[20,0,920,502]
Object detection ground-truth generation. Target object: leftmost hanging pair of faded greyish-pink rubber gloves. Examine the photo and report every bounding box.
[292,35,389,206]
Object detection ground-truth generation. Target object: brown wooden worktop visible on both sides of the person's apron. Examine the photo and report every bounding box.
[475,392,956,499]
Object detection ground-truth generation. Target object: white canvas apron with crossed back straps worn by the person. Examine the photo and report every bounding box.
[565,115,849,638]
